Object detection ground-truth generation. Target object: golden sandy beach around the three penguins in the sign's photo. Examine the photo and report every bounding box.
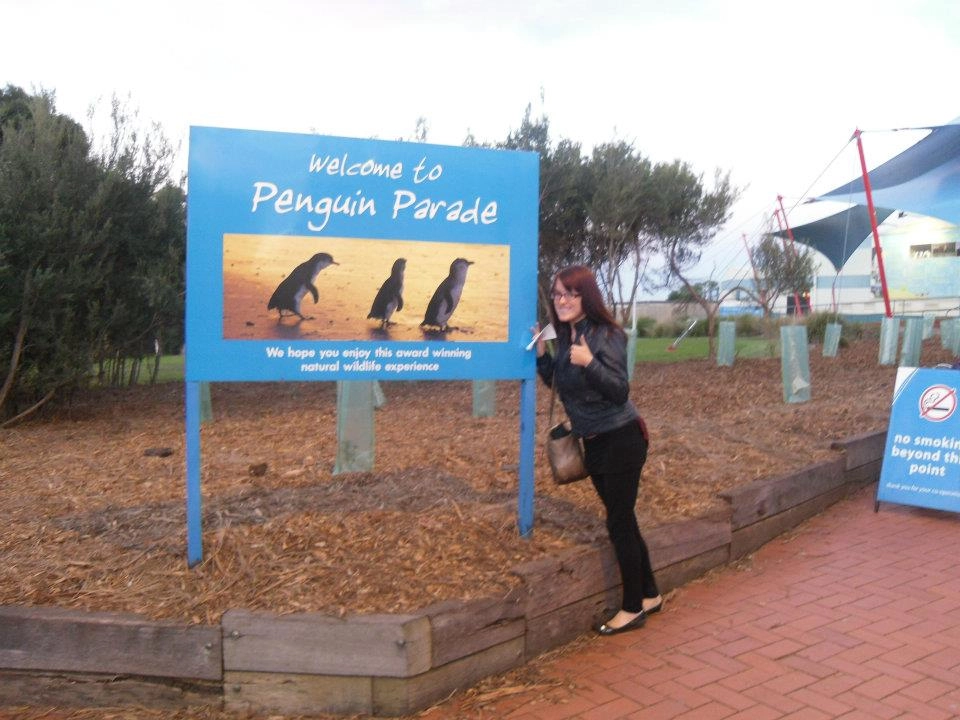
[223,235,510,343]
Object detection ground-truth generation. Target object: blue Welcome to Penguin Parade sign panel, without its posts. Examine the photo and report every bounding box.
[186,127,539,381]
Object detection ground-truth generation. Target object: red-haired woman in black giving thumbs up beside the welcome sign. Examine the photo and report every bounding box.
[536,265,663,635]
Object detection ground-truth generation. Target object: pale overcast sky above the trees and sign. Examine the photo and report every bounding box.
[7,0,960,292]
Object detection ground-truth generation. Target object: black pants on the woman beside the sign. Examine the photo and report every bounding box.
[584,423,660,612]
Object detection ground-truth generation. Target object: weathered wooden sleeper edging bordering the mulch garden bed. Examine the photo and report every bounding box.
[0,432,886,716]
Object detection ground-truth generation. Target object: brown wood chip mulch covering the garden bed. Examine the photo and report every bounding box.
[0,339,951,628]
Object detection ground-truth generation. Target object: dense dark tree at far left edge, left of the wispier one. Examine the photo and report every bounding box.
[0,87,106,417]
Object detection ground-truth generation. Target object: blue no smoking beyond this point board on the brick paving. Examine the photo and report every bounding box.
[877,368,960,512]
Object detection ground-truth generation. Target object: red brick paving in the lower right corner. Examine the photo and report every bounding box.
[420,485,960,720]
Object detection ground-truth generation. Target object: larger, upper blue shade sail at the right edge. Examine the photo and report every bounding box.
[816,121,960,225]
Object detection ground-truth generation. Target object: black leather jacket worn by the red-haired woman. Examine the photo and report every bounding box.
[537,318,638,437]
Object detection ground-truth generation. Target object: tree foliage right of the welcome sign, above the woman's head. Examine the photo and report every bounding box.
[492,106,738,316]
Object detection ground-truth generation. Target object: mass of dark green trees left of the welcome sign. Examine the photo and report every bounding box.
[0,87,185,421]
